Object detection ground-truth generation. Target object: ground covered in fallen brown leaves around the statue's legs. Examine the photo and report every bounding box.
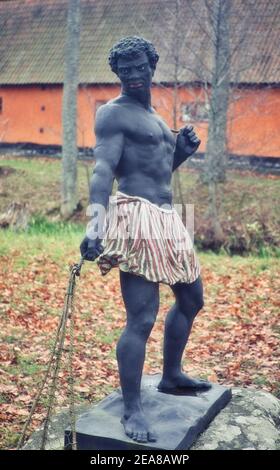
[0,232,280,448]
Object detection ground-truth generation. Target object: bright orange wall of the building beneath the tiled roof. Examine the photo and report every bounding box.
[0,85,280,157]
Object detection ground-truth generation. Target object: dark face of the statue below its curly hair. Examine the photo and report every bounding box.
[118,52,154,95]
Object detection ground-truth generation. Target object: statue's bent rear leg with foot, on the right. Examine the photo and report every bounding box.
[158,277,211,393]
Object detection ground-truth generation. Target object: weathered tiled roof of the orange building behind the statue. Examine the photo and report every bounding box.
[0,0,280,84]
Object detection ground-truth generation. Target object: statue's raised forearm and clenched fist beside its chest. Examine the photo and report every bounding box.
[172,126,201,171]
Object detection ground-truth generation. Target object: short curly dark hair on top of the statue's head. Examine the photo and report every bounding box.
[109,36,159,73]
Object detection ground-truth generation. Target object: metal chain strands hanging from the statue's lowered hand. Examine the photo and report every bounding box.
[17,258,84,450]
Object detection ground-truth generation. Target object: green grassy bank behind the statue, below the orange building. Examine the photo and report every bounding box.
[0,156,280,254]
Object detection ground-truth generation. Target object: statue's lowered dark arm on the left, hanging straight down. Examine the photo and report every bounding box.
[80,105,124,261]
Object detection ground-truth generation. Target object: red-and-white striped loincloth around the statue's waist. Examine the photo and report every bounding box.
[97,191,200,285]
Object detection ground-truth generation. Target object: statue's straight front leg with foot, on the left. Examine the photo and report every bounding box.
[117,271,159,442]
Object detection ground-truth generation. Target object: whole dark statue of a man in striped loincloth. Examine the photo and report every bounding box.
[80,36,210,442]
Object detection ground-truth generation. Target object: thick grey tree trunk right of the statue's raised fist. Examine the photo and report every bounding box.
[202,0,230,184]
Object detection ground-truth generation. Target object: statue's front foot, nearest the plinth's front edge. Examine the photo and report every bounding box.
[121,411,157,442]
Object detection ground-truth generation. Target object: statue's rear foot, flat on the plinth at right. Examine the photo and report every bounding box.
[158,372,212,393]
